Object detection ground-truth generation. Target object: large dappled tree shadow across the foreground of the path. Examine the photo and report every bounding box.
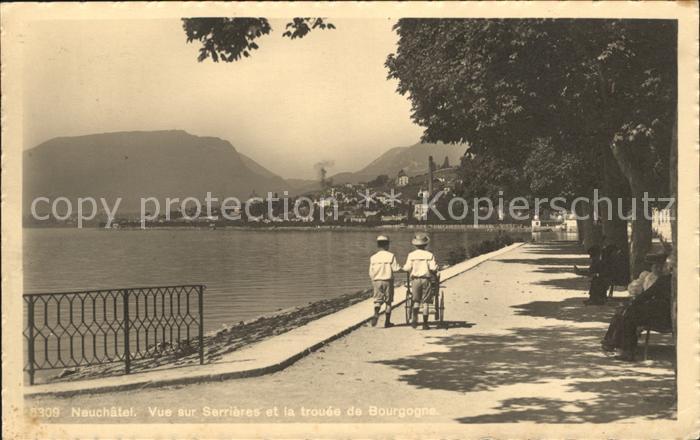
[378,326,674,423]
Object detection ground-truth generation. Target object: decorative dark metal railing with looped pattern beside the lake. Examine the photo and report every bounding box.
[23,285,205,385]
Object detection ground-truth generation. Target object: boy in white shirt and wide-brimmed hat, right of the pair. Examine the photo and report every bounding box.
[403,233,438,330]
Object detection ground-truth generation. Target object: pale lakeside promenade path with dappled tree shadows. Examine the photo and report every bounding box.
[27,242,675,423]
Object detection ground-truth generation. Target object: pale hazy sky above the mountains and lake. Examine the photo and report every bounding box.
[23,17,422,178]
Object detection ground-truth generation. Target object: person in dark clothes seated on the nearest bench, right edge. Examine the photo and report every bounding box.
[602,254,673,361]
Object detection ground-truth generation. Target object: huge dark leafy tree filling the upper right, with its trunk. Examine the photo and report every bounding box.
[386,19,676,275]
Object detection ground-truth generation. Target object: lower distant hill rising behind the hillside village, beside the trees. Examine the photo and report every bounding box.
[331,143,467,184]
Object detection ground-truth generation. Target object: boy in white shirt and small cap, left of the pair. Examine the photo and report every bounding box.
[369,235,401,327]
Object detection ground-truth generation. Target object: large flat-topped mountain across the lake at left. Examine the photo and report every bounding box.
[23,130,287,214]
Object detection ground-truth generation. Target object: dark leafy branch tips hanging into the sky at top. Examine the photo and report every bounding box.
[182,17,335,63]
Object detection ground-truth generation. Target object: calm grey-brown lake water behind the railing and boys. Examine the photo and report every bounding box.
[24,229,564,331]
